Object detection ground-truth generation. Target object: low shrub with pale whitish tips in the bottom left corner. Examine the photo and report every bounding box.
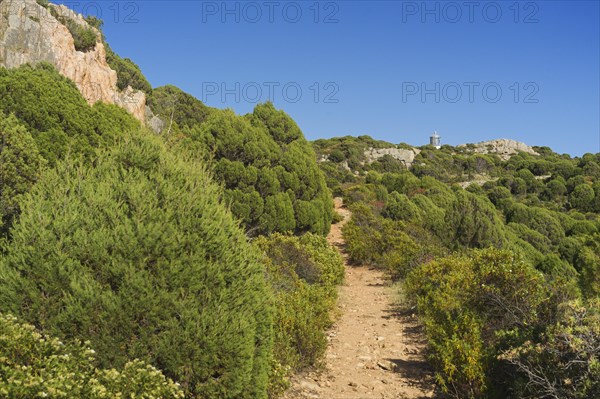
[0,314,184,399]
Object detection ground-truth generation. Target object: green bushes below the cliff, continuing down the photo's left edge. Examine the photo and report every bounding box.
[0,63,140,236]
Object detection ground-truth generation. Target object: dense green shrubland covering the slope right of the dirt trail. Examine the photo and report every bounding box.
[317,137,600,398]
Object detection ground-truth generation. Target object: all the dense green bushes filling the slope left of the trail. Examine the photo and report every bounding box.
[0,52,343,398]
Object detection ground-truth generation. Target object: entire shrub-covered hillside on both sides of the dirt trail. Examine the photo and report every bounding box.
[0,0,600,399]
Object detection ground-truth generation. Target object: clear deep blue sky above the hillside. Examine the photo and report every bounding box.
[58,0,600,155]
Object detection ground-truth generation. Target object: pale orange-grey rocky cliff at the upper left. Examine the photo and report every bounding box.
[0,0,152,124]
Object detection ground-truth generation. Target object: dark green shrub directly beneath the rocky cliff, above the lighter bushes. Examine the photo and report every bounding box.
[0,63,140,166]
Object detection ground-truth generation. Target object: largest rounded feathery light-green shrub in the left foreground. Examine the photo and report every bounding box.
[0,132,271,399]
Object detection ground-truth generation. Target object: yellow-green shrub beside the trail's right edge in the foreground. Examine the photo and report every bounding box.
[405,249,546,398]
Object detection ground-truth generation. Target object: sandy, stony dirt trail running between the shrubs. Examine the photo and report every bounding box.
[285,198,434,399]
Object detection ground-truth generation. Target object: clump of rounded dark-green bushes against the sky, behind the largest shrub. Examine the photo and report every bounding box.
[149,86,333,236]
